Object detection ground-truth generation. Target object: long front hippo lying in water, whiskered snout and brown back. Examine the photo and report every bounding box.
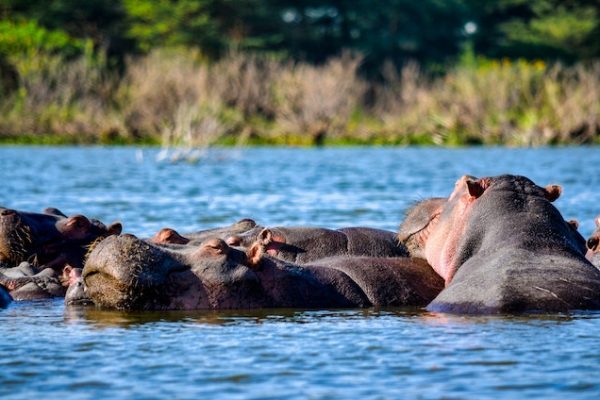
[83,234,444,310]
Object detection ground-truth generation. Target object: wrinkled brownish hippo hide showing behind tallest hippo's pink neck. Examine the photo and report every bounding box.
[398,197,448,259]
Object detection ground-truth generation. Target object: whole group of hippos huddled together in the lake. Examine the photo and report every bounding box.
[0,175,600,314]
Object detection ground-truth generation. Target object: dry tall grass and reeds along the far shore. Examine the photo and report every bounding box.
[0,50,600,148]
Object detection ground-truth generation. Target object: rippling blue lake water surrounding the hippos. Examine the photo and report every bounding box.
[0,147,600,399]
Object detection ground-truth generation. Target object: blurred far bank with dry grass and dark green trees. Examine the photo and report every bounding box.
[0,0,600,148]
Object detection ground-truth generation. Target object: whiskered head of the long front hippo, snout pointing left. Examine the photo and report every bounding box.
[83,234,263,309]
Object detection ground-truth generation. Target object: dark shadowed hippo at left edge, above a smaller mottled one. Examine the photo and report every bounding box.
[0,207,122,272]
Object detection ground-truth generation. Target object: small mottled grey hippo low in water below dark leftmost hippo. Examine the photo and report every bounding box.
[0,261,81,300]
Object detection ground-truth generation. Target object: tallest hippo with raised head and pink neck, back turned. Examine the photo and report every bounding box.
[424,175,600,314]
